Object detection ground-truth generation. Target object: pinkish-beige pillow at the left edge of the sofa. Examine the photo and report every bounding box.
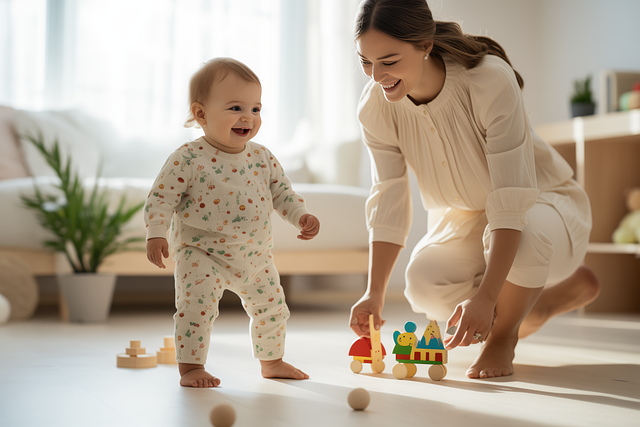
[0,106,29,180]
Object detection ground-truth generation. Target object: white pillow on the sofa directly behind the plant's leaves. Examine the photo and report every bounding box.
[15,110,102,178]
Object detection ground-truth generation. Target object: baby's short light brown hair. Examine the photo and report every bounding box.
[184,58,261,128]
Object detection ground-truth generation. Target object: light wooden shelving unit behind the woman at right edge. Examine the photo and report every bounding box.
[536,110,640,312]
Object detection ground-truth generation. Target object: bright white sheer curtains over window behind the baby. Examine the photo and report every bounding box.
[0,0,362,179]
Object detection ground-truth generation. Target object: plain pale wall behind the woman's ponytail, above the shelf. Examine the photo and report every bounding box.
[436,0,640,127]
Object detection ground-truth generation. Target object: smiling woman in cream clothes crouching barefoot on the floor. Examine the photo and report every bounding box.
[351,0,599,378]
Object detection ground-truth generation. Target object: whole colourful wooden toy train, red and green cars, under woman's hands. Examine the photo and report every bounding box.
[349,318,448,381]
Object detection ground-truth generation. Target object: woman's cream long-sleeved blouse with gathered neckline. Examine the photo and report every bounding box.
[358,55,591,252]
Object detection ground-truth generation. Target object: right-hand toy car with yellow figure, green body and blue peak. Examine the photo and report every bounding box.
[393,320,447,381]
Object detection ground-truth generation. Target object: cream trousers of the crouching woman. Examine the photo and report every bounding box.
[405,204,587,321]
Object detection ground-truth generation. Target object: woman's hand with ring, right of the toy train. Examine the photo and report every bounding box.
[444,295,496,350]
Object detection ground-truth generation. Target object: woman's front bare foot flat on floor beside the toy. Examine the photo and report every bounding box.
[467,337,518,378]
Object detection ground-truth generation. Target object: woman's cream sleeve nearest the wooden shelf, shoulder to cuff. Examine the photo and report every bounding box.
[471,59,540,231]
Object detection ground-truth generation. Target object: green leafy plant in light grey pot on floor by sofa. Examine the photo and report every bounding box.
[21,134,144,322]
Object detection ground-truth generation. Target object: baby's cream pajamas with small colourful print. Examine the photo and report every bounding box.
[144,138,309,364]
